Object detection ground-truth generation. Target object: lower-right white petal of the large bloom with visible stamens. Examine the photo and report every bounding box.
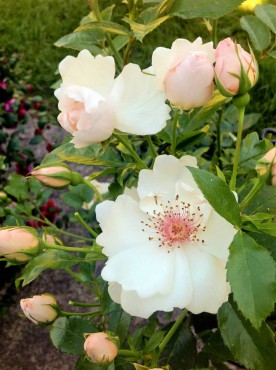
[185,245,229,314]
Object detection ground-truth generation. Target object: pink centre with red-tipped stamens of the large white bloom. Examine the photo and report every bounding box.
[141,195,205,252]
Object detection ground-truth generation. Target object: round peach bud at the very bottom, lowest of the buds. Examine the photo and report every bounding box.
[84,332,118,364]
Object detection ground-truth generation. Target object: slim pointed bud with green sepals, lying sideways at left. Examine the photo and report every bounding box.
[31,163,82,189]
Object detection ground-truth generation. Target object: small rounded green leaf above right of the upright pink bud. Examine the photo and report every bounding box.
[240,15,271,51]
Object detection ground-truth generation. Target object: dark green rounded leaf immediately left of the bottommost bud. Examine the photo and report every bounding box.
[50,316,97,355]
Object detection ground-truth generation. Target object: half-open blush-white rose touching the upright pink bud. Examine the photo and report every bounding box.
[148,37,215,110]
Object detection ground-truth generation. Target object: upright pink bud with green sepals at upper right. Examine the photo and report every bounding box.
[215,37,258,96]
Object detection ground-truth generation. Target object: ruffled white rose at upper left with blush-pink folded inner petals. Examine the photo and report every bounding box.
[55,50,170,148]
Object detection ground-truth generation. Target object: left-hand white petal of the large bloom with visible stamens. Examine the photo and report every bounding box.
[96,195,149,256]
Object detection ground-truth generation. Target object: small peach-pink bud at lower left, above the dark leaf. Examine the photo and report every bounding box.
[20,293,58,325]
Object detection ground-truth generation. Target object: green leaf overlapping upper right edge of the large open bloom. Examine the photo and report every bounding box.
[189,167,241,226]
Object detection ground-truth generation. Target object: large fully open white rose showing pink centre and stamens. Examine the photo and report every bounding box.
[96,155,235,318]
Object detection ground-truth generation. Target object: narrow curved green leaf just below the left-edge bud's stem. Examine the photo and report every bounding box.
[17,249,80,287]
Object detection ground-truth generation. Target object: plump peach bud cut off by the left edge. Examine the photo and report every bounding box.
[0,227,39,262]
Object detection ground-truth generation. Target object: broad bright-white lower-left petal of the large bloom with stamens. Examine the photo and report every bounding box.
[102,244,175,298]
